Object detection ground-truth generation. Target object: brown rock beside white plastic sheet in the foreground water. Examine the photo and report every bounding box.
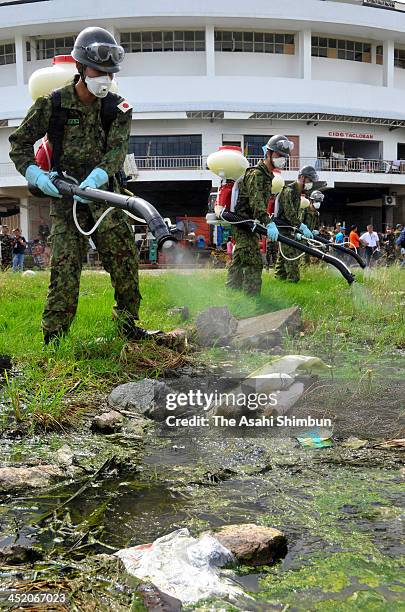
[211,523,287,566]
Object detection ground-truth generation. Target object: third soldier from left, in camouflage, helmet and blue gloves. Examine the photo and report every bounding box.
[275,166,318,283]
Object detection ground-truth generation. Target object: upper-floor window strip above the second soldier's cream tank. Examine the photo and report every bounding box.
[215,30,295,55]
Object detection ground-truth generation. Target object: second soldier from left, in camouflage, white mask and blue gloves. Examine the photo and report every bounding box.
[226,135,293,295]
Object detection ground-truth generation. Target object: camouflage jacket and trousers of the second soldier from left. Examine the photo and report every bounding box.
[226,161,274,295]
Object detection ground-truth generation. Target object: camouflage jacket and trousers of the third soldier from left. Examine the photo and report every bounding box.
[276,183,302,282]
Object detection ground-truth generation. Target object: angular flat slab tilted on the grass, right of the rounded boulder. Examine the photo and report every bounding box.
[232,306,302,349]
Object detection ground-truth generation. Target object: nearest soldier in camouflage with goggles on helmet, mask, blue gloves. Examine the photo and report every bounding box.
[10,28,146,343]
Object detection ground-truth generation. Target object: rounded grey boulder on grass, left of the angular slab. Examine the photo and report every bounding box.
[195,306,238,346]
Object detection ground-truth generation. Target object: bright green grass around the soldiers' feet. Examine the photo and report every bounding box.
[0,266,405,426]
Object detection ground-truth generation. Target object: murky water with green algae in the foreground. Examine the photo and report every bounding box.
[0,436,405,610]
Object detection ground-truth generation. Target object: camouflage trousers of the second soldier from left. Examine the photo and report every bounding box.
[226,230,263,295]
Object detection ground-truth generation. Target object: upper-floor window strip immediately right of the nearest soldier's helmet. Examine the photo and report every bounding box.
[120,30,205,53]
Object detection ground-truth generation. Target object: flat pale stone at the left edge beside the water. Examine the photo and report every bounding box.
[0,465,69,493]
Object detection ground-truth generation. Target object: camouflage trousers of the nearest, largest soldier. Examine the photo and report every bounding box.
[42,198,141,334]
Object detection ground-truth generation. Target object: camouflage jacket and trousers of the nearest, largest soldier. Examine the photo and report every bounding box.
[10,81,141,335]
